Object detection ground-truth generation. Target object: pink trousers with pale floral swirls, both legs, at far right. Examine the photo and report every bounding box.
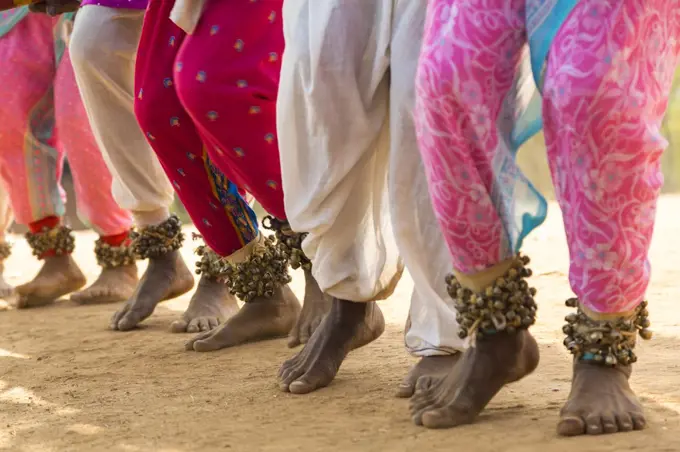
[415,0,680,313]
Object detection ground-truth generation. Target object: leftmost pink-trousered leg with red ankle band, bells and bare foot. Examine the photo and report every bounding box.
[0,15,86,308]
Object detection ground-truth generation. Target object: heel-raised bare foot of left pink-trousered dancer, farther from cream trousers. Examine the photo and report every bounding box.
[16,255,87,309]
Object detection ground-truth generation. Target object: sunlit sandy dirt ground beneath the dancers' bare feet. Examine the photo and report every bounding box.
[0,197,680,452]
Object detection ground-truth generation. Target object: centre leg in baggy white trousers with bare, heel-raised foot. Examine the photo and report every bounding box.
[277,0,402,393]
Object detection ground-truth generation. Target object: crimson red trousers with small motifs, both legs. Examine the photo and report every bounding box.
[135,0,286,256]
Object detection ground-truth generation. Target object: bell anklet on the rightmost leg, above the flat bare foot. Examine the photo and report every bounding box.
[562,298,652,366]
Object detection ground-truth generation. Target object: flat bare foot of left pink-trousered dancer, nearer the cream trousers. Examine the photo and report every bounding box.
[71,264,139,304]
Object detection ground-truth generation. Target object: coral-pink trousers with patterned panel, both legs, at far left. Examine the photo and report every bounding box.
[0,14,132,236]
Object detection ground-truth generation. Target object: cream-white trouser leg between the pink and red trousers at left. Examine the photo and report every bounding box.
[69,5,174,226]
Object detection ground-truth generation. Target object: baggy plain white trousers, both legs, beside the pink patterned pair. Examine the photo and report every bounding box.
[277,0,463,356]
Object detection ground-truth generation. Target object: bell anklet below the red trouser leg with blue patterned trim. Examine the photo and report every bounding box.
[220,237,292,303]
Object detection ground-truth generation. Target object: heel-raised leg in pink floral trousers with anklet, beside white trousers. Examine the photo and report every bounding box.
[411,0,538,428]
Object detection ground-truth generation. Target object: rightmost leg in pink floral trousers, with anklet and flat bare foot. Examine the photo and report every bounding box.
[543,0,680,436]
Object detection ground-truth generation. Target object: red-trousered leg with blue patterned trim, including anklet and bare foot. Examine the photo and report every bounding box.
[135,1,299,340]
